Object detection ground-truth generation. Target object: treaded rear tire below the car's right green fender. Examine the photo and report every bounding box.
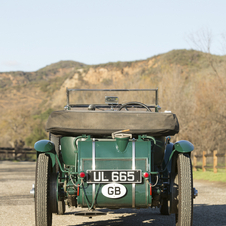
[174,154,193,226]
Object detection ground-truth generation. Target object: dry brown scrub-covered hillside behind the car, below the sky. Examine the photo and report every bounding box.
[0,50,226,154]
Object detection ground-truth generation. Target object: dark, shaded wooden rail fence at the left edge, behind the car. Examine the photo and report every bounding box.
[0,147,36,160]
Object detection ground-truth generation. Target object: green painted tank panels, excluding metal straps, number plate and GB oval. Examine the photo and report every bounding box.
[77,139,152,208]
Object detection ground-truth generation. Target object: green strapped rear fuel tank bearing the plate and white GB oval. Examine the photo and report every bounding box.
[77,139,151,208]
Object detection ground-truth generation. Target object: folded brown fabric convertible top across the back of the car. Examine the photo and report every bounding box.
[46,110,179,136]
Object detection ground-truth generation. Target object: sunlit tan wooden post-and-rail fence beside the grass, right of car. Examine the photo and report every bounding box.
[193,151,226,173]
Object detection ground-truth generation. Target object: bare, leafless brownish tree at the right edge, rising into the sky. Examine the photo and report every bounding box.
[188,29,226,154]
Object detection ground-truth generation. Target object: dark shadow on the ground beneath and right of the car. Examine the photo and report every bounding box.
[62,205,226,226]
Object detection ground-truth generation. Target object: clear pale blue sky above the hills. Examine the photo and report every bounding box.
[0,0,226,72]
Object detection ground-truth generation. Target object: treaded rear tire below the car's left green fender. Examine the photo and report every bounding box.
[35,154,52,226]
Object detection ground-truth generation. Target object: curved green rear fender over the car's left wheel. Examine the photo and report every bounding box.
[34,140,56,167]
